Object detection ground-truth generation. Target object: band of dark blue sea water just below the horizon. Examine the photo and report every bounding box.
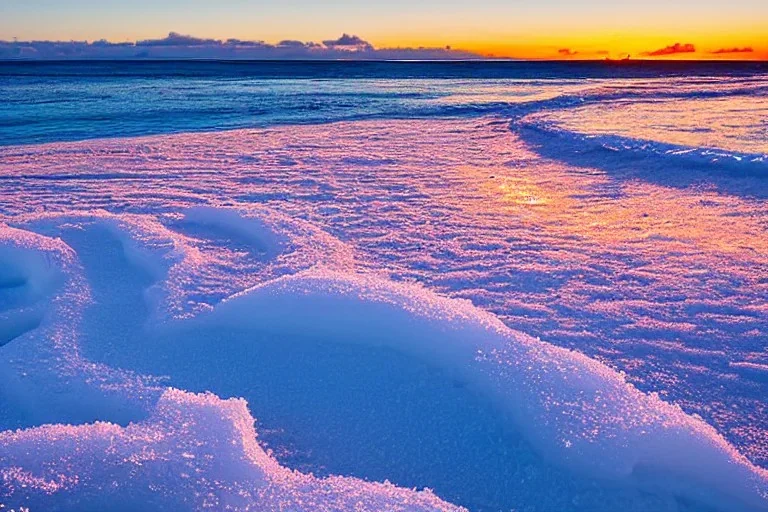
[0,61,768,145]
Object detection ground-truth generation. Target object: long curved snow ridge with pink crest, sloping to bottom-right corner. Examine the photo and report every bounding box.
[206,269,768,511]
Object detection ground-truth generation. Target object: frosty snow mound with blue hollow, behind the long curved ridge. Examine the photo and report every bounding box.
[18,205,355,322]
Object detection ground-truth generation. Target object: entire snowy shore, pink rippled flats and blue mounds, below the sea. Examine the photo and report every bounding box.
[0,111,768,512]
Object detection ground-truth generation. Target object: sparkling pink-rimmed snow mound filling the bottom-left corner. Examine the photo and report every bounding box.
[0,389,462,511]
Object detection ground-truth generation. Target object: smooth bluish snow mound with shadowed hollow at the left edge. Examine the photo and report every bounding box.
[0,225,158,430]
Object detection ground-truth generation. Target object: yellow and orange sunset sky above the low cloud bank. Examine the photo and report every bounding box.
[0,0,768,59]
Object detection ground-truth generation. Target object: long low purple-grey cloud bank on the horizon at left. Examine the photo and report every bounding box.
[0,32,484,60]
